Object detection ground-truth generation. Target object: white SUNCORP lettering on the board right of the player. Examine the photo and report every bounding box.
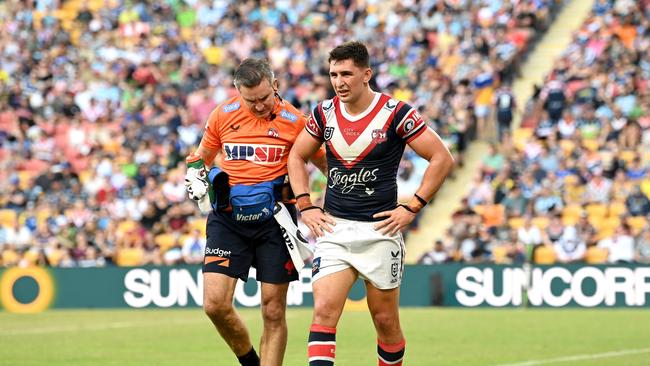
[455,267,650,307]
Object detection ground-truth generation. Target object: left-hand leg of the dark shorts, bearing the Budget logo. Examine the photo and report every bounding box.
[203,212,255,281]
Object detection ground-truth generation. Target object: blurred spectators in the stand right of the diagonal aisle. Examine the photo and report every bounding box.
[420,0,650,264]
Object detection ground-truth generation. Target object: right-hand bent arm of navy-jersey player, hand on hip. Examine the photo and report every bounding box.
[374,127,454,235]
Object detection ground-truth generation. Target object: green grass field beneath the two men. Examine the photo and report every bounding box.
[0,308,650,366]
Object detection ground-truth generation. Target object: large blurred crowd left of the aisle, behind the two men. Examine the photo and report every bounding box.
[0,0,560,267]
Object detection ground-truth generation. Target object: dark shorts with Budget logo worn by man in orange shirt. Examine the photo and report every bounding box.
[203,205,298,283]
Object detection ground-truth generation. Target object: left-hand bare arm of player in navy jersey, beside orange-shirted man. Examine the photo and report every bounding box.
[287,130,334,237]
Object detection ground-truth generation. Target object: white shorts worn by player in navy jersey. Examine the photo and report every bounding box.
[312,217,406,290]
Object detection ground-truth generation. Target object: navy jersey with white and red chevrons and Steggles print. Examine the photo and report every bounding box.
[305,93,427,221]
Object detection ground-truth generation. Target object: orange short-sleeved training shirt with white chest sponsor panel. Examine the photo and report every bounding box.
[201,96,306,185]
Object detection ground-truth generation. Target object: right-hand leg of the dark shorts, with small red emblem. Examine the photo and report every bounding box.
[253,220,298,284]
